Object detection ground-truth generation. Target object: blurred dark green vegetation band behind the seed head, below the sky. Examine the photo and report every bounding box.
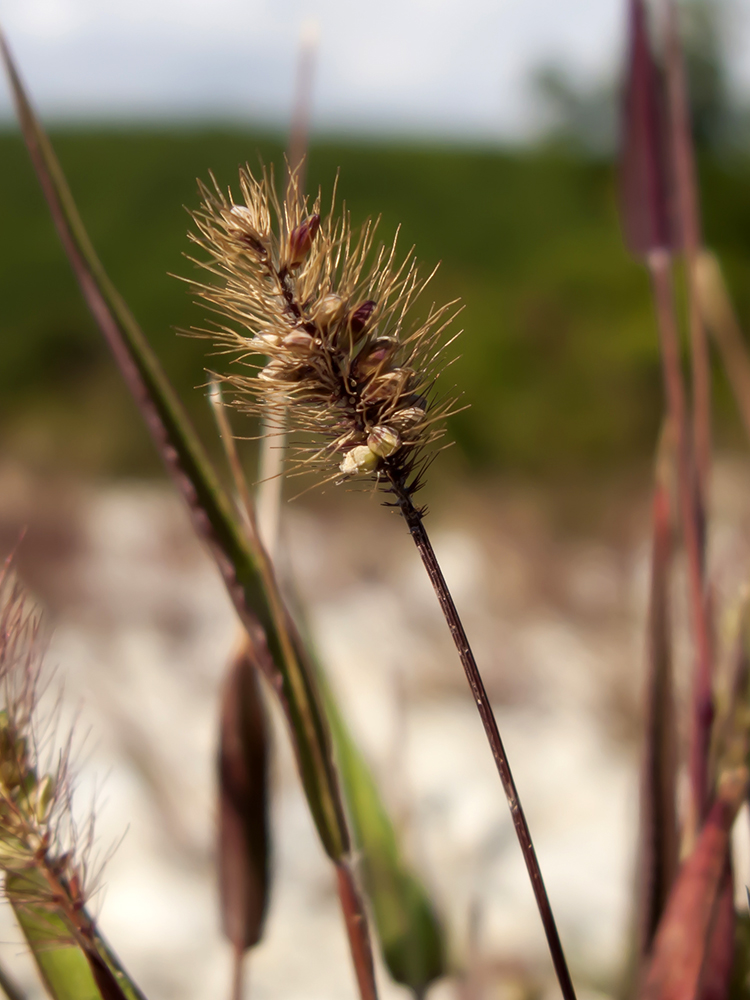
[0,129,750,473]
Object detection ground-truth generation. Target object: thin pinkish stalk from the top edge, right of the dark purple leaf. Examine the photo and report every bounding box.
[665,0,711,516]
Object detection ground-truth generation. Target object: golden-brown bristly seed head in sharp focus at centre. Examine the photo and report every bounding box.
[191,168,464,493]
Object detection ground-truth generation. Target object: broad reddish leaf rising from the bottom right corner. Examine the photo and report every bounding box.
[639,767,747,1000]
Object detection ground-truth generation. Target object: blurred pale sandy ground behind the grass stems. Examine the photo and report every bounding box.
[0,460,750,1000]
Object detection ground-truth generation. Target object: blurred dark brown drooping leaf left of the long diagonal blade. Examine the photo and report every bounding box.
[218,645,269,1000]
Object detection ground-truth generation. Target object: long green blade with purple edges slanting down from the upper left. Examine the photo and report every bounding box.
[0,34,348,860]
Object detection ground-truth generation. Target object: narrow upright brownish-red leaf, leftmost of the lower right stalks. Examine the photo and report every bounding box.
[638,425,679,959]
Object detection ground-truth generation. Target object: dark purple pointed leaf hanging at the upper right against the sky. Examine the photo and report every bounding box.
[620,0,671,256]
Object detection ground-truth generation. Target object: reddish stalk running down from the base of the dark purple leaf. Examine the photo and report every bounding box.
[648,250,714,833]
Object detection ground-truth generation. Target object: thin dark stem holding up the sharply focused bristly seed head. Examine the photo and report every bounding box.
[388,473,576,1000]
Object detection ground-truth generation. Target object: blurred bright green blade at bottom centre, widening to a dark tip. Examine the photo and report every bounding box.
[324,686,446,997]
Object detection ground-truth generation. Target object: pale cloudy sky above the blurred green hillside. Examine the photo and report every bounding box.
[0,0,750,138]
